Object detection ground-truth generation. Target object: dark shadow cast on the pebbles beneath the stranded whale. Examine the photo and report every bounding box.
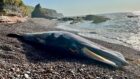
[22,42,116,70]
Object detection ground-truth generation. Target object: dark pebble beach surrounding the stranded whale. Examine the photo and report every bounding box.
[0,18,140,79]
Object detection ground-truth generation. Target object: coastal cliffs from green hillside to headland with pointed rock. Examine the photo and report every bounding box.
[0,0,63,19]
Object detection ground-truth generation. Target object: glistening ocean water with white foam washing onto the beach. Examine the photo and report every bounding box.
[57,12,140,50]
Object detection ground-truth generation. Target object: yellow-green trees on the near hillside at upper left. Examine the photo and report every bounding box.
[0,0,28,16]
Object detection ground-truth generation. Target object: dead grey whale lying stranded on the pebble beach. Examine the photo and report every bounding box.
[7,31,128,67]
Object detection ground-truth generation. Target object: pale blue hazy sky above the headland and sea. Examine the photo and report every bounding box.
[23,0,140,16]
